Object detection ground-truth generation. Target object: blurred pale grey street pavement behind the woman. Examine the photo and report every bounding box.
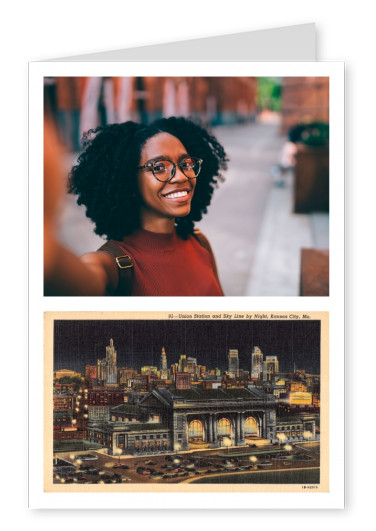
[60,120,329,296]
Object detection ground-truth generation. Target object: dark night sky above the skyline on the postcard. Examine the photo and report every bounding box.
[54,320,320,374]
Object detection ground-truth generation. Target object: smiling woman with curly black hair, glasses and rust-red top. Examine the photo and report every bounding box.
[47,118,227,296]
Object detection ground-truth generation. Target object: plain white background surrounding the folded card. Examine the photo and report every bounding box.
[0,0,375,530]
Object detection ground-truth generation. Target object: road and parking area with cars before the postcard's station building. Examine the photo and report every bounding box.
[54,442,320,484]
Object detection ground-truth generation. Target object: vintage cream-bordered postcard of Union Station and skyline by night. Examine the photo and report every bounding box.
[44,312,330,493]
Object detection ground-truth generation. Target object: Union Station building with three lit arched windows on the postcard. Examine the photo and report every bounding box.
[87,388,318,455]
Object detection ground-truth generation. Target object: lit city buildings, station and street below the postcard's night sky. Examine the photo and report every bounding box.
[54,324,320,485]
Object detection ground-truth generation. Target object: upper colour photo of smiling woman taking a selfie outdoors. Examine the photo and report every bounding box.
[44,76,329,297]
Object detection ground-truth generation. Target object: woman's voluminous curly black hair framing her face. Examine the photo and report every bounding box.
[68,117,228,240]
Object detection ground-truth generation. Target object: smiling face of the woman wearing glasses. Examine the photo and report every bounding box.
[138,133,196,232]
